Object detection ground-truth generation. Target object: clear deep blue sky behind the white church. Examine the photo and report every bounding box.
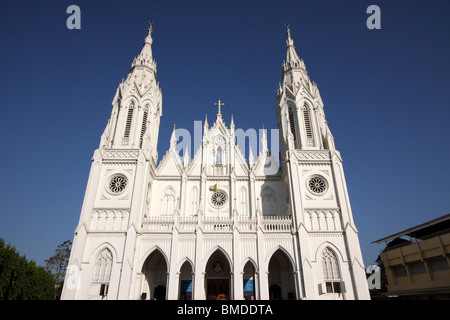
[0,0,450,265]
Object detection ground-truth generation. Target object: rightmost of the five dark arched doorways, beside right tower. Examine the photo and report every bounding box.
[268,249,296,300]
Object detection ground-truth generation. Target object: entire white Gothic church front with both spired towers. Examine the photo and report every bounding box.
[62,26,370,300]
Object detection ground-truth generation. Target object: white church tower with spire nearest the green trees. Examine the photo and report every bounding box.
[62,24,162,299]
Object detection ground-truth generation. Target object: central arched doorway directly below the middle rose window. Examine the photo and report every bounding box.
[205,249,232,300]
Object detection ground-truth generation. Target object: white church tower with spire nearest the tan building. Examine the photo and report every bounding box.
[276,27,368,299]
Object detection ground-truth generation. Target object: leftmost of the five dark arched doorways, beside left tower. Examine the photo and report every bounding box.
[141,250,167,300]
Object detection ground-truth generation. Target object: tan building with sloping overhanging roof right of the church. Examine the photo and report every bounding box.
[374,214,450,300]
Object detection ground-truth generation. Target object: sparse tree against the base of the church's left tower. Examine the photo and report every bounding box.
[45,240,72,299]
